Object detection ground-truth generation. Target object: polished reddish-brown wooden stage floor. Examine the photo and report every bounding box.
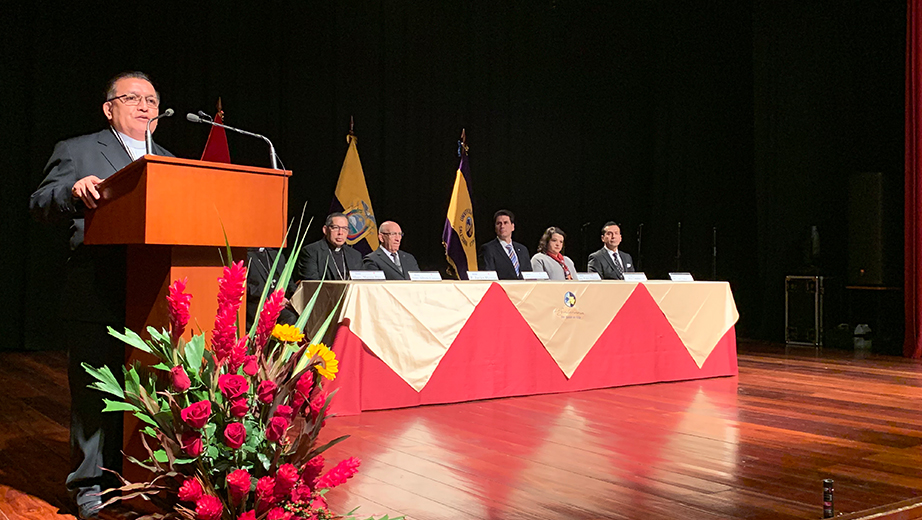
[0,342,922,520]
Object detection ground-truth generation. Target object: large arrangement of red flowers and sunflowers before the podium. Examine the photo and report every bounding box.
[84,244,398,520]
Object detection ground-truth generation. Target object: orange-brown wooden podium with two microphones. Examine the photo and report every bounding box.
[84,155,291,481]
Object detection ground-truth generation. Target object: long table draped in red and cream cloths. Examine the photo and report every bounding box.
[292,281,739,415]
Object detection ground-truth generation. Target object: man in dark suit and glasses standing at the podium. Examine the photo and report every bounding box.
[29,72,172,518]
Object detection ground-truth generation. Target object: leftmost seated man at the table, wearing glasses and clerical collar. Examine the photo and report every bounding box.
[296,212,362,280]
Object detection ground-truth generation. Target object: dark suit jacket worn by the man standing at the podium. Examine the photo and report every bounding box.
[29,128,173,326]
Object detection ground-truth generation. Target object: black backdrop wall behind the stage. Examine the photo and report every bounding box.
[0,0,906,348]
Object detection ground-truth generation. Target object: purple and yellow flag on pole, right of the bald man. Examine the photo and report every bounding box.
[442,132,477,280]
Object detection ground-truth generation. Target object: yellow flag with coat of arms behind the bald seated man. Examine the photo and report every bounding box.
[330,133,378,255]
